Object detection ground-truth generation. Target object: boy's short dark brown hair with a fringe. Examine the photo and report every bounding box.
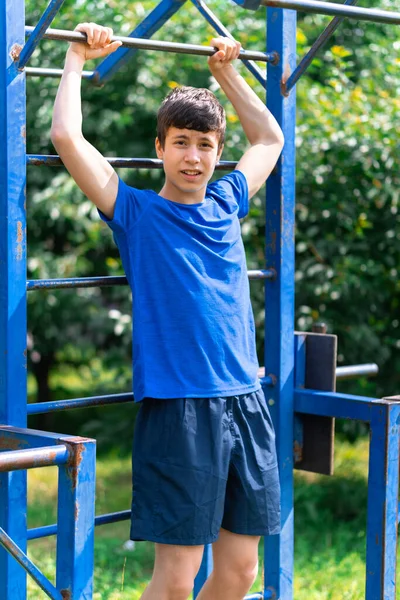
[157,86,226,147]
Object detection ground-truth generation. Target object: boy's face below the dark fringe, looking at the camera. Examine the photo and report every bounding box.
[156,127,222,204]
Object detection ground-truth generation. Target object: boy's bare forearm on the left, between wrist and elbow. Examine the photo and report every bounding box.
[51,51,85,139]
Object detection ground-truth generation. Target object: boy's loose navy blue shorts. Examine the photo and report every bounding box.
[131,389,280,546]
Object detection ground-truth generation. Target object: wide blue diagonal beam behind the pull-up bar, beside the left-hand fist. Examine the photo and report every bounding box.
[96,0,186,82]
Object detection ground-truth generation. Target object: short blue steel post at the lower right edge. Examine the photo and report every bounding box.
[365,396,400,600]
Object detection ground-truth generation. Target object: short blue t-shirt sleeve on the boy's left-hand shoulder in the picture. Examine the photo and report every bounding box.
[98,179,147,234]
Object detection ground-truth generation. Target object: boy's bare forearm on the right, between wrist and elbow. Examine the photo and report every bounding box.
[211,65,283,145]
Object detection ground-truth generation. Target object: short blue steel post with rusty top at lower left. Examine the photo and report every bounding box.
[57,438,96,600]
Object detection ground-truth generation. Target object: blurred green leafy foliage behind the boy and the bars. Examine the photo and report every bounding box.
[27,0,400,428]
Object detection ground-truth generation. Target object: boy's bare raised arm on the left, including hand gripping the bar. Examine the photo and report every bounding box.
[51,23,121,219]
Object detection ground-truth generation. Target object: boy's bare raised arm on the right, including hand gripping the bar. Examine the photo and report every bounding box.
[208,37,284,197]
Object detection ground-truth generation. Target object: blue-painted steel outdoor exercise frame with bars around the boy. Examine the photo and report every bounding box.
[0,0,400,600]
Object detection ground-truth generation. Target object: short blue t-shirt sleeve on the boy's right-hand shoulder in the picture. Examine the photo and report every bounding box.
[207,170,249,219]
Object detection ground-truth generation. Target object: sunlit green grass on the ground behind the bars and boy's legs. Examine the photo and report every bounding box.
[28,439,400,600]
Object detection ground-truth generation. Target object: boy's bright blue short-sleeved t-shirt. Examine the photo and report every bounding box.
[100,171,260,401]
